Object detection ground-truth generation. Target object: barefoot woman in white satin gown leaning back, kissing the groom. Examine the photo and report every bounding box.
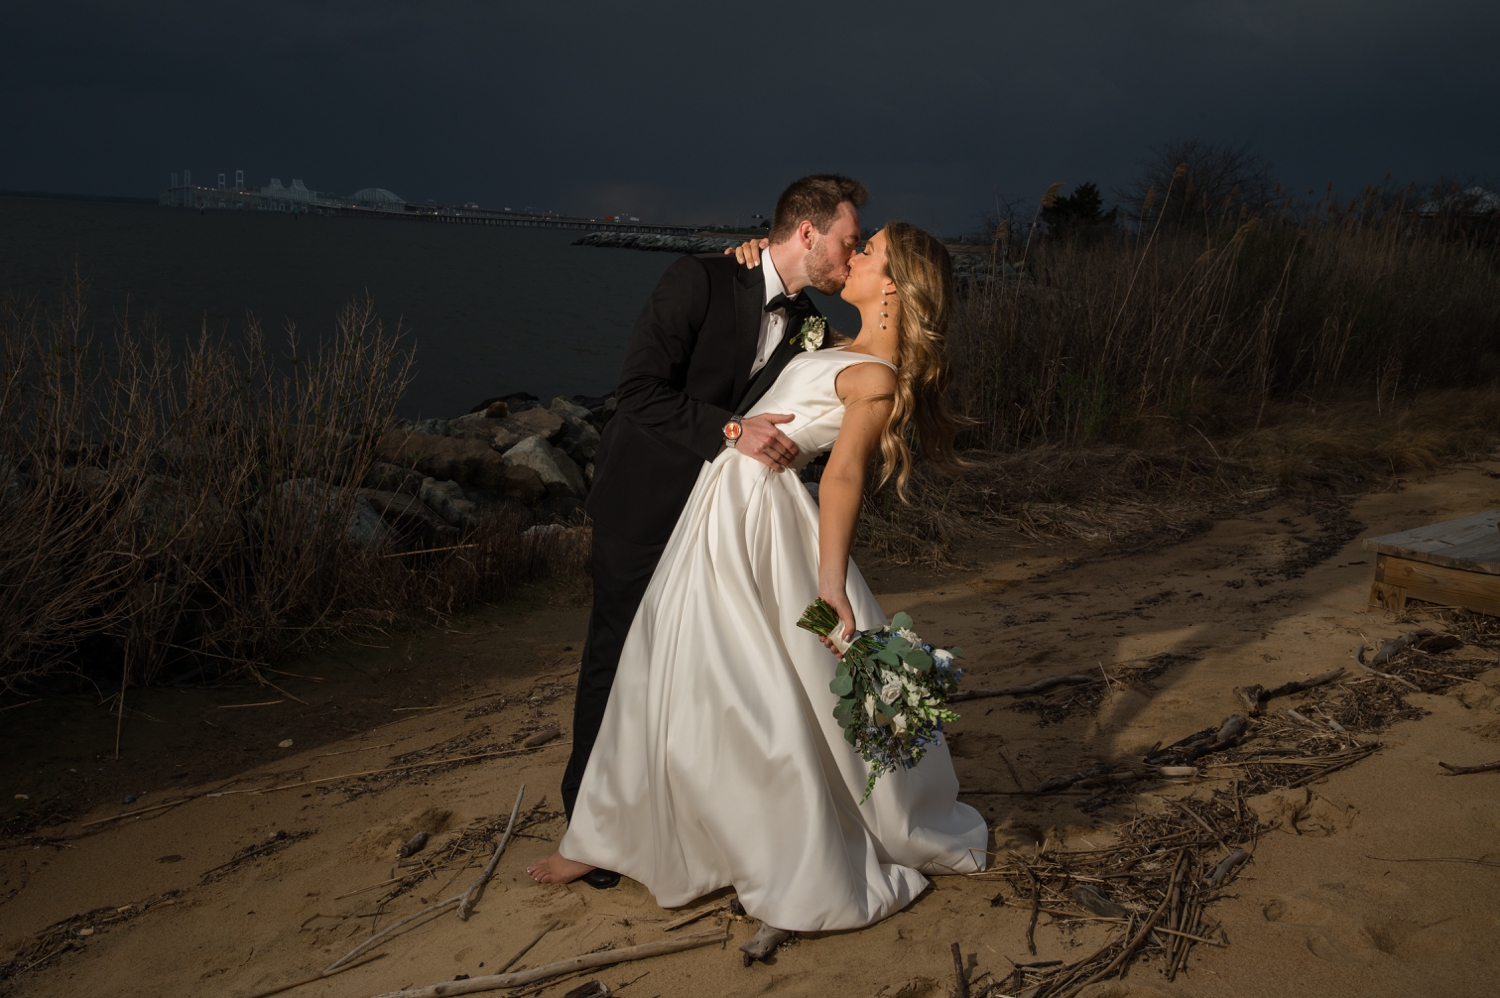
[528,222,987,956]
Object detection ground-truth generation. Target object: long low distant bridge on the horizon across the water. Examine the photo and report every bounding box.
[158,185,702,236]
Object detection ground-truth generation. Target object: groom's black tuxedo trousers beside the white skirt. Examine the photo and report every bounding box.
[563,522,666,821]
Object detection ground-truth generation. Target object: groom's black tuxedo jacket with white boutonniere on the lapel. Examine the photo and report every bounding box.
[588,254,831,545]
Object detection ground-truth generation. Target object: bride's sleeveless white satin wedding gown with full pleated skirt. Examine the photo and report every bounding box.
[558,350,987,932]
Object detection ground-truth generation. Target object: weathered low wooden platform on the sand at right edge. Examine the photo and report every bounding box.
[1365,510,1500,617]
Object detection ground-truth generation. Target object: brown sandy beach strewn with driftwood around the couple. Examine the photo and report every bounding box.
[0,462,1500,998]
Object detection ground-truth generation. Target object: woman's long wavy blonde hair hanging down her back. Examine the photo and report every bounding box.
[881,222,960,501]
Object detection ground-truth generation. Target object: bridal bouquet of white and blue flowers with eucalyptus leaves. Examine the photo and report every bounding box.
[797,599,963,804]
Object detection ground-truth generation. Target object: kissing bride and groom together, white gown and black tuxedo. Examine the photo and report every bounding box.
[528,174,989,962]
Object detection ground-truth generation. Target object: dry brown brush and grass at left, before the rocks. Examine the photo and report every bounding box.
[0,284,579,692]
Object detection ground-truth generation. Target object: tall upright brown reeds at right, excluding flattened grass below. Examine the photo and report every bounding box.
[951,191,1500,450]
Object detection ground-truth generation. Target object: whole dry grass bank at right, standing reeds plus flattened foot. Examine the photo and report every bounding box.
[861,183,1500,564]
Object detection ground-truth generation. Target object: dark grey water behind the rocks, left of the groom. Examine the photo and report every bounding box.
[0,198,854,417]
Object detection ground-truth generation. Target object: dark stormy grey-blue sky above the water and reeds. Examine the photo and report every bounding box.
[0,0,1500,234]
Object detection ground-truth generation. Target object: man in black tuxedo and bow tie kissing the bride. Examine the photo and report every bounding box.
[549,174,869,887]
